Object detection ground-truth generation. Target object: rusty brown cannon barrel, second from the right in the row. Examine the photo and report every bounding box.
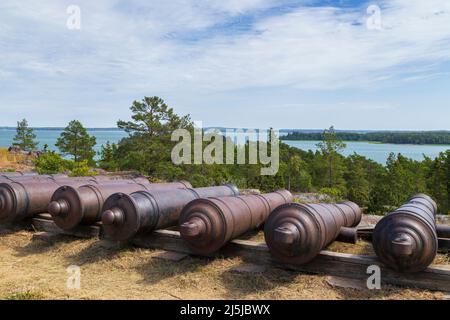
[264,201,362,264]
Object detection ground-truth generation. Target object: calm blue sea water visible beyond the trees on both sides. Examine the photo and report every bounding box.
[0,129,450,164]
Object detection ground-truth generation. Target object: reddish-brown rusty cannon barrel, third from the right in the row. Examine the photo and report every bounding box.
[179,190,293,255]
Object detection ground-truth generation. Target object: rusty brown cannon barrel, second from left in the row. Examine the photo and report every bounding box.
[48,178,192,230]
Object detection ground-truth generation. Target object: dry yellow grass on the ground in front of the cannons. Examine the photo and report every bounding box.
[0,226,448,299]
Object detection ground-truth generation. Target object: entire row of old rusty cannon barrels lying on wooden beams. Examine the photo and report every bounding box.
[0,173,450,272]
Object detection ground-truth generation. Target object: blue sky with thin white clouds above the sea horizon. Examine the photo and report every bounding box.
[0,0,450,130]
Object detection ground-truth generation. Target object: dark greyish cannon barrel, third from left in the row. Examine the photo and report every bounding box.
[102,185,239,241]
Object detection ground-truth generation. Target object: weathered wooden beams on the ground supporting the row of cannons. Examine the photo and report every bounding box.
[29,218,450,292]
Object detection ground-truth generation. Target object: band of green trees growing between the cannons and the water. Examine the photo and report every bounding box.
[10,97,450,214]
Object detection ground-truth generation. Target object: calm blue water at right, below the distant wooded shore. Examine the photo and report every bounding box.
[285,141,450,164]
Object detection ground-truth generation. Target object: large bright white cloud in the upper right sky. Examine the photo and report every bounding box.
[177,0,450,89]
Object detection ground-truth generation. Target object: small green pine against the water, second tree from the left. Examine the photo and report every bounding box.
[55,120,96,165]
